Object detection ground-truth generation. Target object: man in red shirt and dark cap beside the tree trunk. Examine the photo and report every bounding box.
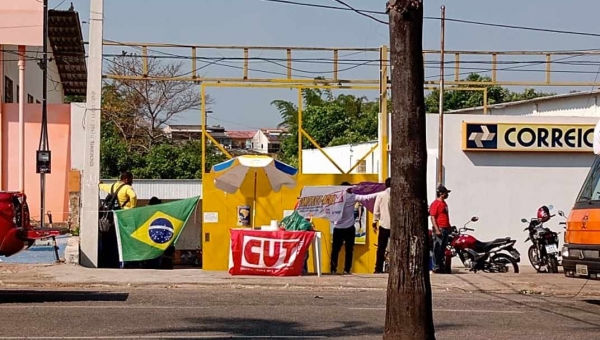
[429,185,450,273]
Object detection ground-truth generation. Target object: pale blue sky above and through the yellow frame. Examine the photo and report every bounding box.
[49,0,600,130]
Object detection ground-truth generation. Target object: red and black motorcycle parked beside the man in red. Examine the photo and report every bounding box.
[446,216,521,273]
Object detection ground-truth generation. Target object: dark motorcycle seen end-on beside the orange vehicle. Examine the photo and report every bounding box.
[521,205,560,273]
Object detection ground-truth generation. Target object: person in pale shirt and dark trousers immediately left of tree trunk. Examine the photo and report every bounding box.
[373,177,391,274]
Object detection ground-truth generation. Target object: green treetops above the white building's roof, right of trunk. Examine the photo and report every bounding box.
[425,73,554,113]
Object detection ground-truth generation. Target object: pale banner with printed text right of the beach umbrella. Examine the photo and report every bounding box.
[296,186,348,222]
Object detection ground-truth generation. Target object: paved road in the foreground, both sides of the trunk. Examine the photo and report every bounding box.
[0,288,600,340]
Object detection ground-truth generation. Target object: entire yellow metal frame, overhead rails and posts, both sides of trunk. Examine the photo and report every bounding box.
[103,41,600,180]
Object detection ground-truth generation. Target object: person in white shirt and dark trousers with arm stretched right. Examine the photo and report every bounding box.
[330,182,377,275]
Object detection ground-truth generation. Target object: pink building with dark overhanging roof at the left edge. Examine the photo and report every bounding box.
[0,0,87,226]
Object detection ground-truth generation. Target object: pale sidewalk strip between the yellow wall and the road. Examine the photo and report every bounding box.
[0,264,600,296]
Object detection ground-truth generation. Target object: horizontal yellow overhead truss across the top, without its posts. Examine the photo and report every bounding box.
[103,40,600,90]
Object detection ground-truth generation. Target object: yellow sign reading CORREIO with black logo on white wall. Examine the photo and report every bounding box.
[462,122,594,152]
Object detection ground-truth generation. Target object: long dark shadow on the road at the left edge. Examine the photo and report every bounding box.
[0,290,129,304]
